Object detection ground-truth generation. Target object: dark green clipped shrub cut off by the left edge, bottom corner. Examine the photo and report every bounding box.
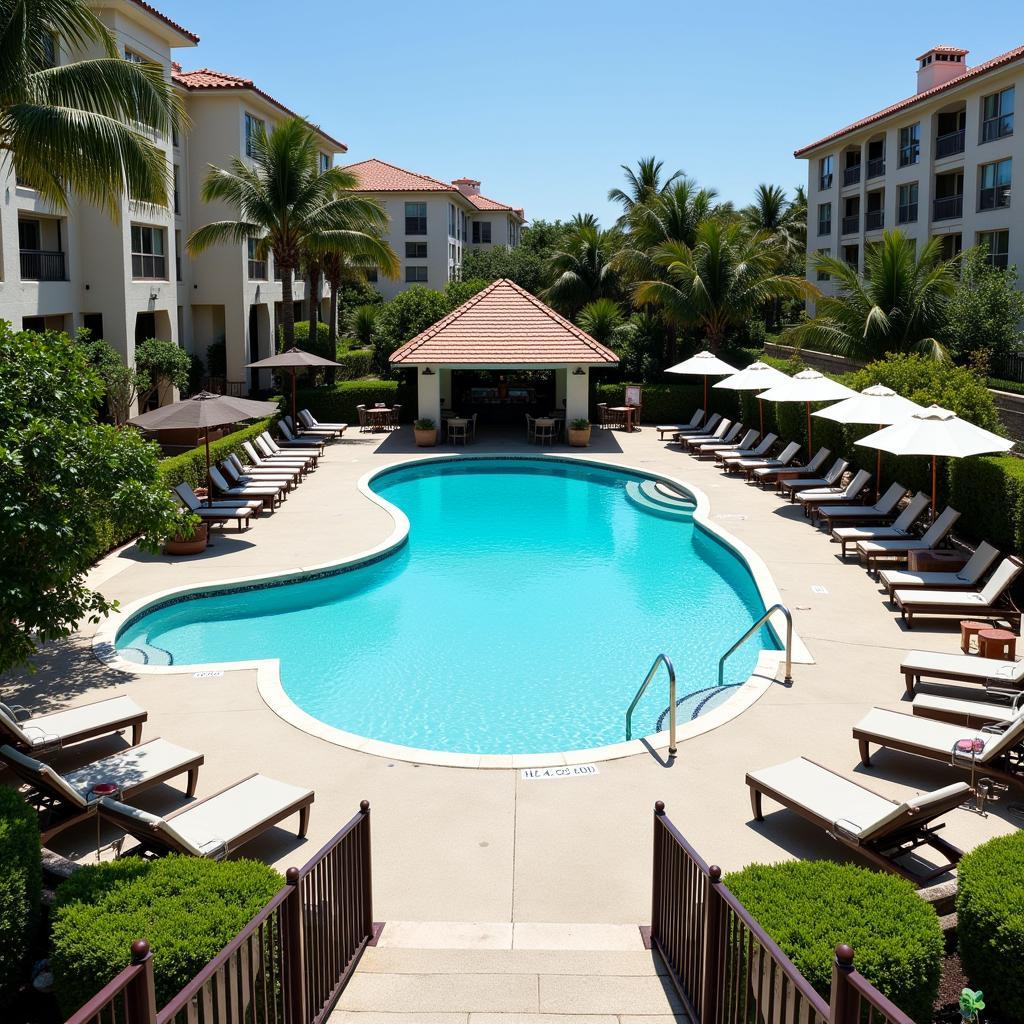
[0,785,43,1007]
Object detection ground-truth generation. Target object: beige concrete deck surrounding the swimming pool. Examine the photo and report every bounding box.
[0,427,1019,934]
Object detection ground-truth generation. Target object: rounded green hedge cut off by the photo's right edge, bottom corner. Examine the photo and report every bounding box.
[956,833,1024,1021]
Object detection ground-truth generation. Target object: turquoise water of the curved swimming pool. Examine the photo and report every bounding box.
[118,459,776,754]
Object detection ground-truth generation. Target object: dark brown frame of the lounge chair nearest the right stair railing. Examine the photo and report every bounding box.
[746,759,964,886]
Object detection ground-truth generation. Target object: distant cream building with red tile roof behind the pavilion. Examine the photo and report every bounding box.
[347,160,525,298]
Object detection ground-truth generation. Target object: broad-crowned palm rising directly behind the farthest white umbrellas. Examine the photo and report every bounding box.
[633,217,817,350]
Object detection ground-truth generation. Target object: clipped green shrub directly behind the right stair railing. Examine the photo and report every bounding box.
[725,860,943,1024]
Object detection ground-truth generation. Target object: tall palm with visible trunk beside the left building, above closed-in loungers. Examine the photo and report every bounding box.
[188,118,398,348]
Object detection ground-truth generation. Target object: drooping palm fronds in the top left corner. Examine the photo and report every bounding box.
[0,0,183,209]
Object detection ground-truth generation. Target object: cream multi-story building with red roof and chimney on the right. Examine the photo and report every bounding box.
[796,46,1024,311]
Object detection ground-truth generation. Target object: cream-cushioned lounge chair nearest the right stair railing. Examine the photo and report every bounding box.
[746,758,971,886]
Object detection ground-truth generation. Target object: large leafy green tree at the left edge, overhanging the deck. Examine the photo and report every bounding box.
[0,322,181,672]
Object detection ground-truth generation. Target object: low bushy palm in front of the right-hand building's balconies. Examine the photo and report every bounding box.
[783,230,958,361]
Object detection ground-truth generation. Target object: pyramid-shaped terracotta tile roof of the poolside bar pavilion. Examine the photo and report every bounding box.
[391,278,618,367]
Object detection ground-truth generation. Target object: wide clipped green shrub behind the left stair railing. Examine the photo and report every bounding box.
[50,856,284,1015]
